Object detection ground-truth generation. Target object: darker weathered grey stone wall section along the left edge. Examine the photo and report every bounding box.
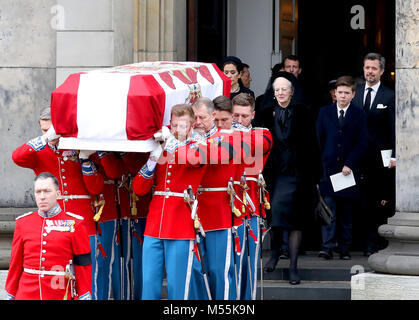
[0,0,56,207]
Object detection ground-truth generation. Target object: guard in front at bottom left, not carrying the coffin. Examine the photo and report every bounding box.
[6,172,91,300]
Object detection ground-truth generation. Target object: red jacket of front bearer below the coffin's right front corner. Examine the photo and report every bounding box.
[132,140,206,239]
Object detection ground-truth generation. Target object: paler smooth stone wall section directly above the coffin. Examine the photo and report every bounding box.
[57,0,134,86]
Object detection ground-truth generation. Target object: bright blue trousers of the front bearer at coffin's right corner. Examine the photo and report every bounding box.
[142,236,208,300]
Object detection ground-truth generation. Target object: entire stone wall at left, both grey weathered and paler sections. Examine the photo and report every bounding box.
[0,0,135,207]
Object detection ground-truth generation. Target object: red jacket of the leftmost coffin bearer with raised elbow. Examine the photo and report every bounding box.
[12,137,103,235]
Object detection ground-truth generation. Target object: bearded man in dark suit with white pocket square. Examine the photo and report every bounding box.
[353,53,396,256]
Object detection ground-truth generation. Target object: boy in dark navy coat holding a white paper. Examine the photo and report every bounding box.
[317,76,367,260]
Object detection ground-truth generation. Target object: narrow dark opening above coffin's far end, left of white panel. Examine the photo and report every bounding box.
[187,0,227,63]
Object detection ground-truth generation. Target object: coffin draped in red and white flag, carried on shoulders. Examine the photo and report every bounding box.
[51,61,231,152]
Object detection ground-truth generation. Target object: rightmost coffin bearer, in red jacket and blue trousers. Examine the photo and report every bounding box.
[232,93,272,300]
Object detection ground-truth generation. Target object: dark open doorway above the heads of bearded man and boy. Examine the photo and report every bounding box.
[298,0,395,114]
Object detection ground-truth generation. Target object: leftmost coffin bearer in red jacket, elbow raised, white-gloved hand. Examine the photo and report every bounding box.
[12,108,103,298]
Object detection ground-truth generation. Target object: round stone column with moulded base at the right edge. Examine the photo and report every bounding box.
[368,0,419,275]
